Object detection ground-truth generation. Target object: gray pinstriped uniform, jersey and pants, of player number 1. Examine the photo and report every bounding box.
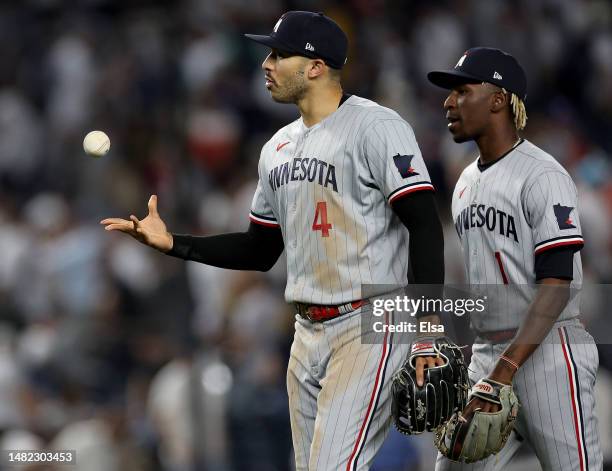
[436,141,603,471]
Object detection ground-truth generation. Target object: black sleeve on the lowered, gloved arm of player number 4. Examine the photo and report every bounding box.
[393,191,444,285]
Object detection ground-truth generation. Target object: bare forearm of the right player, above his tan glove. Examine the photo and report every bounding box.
[491,278,570,383]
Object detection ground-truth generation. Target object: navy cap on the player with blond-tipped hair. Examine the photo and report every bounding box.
[427,47,527,100]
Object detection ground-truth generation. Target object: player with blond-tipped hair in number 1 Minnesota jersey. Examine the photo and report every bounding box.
[428,47,602,471]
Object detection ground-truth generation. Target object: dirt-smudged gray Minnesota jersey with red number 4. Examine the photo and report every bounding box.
[250,96,433,305]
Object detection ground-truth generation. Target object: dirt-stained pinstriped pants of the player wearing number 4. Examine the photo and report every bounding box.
[287,309,409,471]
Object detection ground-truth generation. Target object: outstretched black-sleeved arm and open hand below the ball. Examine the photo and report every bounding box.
[100,195,284,271]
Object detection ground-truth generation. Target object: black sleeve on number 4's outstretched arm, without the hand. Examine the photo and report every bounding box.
[167,223,285,271]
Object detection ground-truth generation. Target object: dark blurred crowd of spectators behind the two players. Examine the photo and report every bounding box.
[0,0,612,471]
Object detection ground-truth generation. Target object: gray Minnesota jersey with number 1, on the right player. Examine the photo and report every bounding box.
[452,140,584,331]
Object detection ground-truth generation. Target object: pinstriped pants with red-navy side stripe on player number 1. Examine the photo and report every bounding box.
[436,320,603,471]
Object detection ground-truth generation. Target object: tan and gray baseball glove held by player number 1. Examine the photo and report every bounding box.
[434,378,520,463]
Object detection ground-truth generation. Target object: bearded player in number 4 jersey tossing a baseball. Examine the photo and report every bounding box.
[101,11,444,471]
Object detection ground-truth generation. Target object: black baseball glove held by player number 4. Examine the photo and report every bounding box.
[391,337,470,435]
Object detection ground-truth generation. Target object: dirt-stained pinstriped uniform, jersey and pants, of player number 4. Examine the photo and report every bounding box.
[250,96,433,471]
